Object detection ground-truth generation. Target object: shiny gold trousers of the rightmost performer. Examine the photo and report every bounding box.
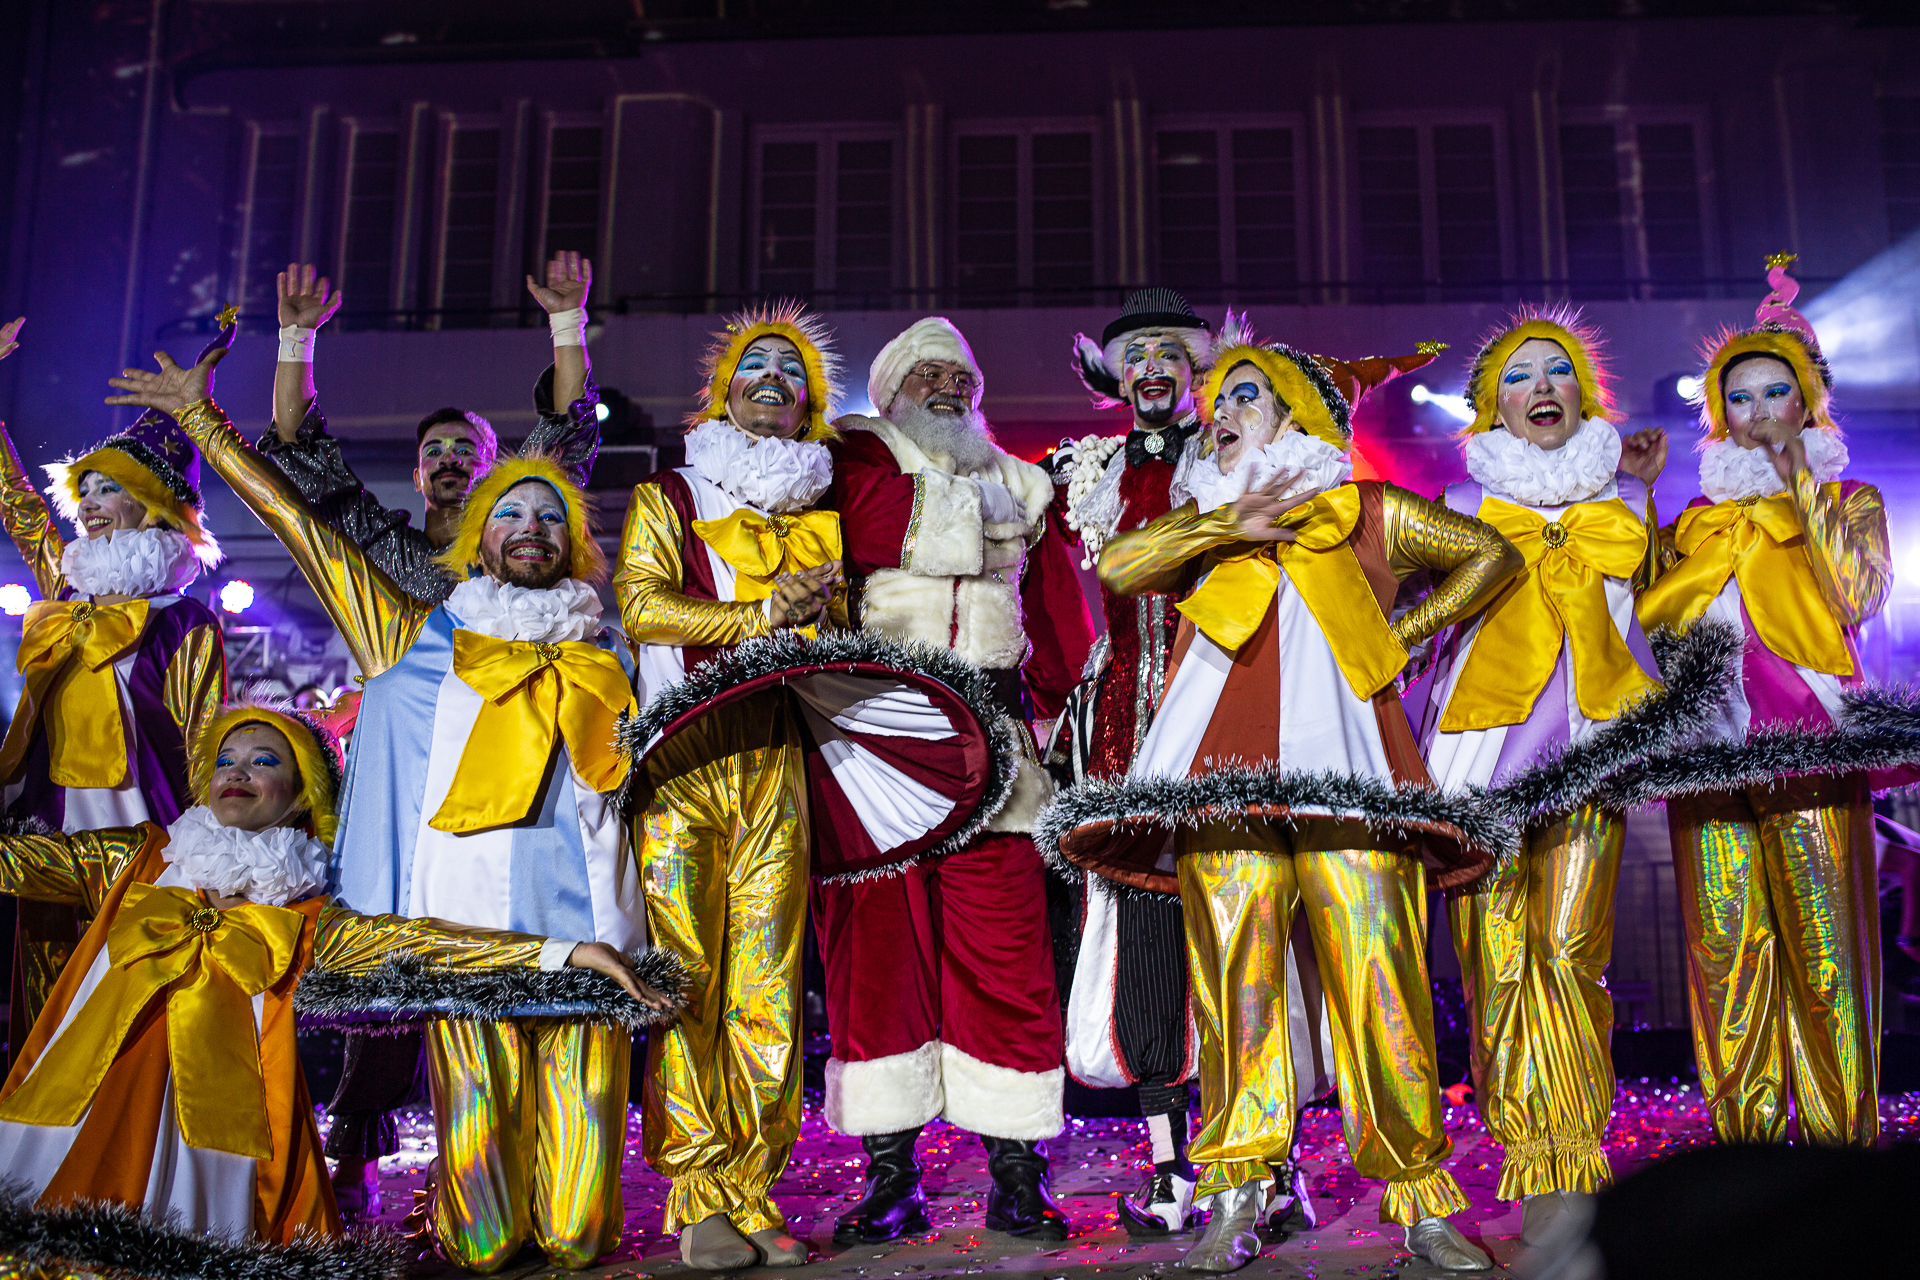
[1667,773,1880,1148]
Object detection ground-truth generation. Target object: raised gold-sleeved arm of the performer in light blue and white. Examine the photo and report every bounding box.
[108,349,432,676]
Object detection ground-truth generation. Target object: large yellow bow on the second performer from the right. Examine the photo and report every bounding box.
[1440,497,1657,733]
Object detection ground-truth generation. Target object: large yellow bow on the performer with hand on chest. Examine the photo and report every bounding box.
[1175,484,1407,699]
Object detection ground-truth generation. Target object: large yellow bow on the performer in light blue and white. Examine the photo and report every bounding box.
[428,629,634,835]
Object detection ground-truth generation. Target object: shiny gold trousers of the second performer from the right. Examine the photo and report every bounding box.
[1448,808,1626,1199]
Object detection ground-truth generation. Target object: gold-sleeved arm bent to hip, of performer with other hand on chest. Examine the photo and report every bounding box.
[1382,484,1526,649]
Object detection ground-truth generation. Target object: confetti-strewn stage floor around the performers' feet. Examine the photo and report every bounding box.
[337,1082,1920,1280]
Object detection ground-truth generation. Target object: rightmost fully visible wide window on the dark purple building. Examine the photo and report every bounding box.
[1559,121,1707,297]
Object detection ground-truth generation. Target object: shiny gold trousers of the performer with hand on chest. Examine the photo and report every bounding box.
[1179,819,1467,1226]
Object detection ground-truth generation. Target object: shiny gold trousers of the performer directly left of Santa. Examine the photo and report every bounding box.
[636,691,808,1232]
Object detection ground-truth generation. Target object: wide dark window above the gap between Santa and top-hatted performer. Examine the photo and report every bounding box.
[952,129,1094,305]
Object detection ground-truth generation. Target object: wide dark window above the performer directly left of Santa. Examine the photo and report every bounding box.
[755,134,895,307]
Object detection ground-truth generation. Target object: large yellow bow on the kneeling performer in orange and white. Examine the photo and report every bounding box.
[0,885,307,1159]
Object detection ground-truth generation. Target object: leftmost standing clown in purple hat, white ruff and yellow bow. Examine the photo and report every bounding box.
[0,317,236,1054]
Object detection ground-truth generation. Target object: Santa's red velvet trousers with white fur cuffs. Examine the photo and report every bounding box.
[812,833,1066,1140]
